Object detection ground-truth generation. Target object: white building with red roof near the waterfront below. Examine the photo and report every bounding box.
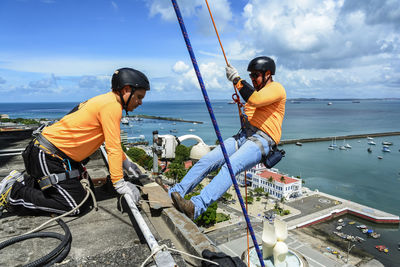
[236,164,302,199]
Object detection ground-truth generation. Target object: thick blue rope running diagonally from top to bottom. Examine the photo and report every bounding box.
[171,0,265,267]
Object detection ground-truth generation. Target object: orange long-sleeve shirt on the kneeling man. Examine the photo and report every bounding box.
[42,92,126,183]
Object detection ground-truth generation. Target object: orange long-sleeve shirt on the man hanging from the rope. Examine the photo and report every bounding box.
[245,82,286,144]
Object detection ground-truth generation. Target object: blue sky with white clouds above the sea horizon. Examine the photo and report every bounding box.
[0,0,400,102]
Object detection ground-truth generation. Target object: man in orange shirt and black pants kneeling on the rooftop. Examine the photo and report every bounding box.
[0,68,150,217]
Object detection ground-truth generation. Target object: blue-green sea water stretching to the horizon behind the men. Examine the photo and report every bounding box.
[0,100,400,264]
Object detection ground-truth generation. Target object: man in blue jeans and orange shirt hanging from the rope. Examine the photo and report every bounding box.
[169,57,286,219]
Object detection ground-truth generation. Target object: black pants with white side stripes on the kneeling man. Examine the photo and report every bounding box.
[9,141,88,215]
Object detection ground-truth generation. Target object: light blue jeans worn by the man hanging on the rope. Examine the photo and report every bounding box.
[168,131,270,218]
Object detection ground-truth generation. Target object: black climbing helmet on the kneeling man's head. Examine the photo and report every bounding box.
[111,68,150,91]
